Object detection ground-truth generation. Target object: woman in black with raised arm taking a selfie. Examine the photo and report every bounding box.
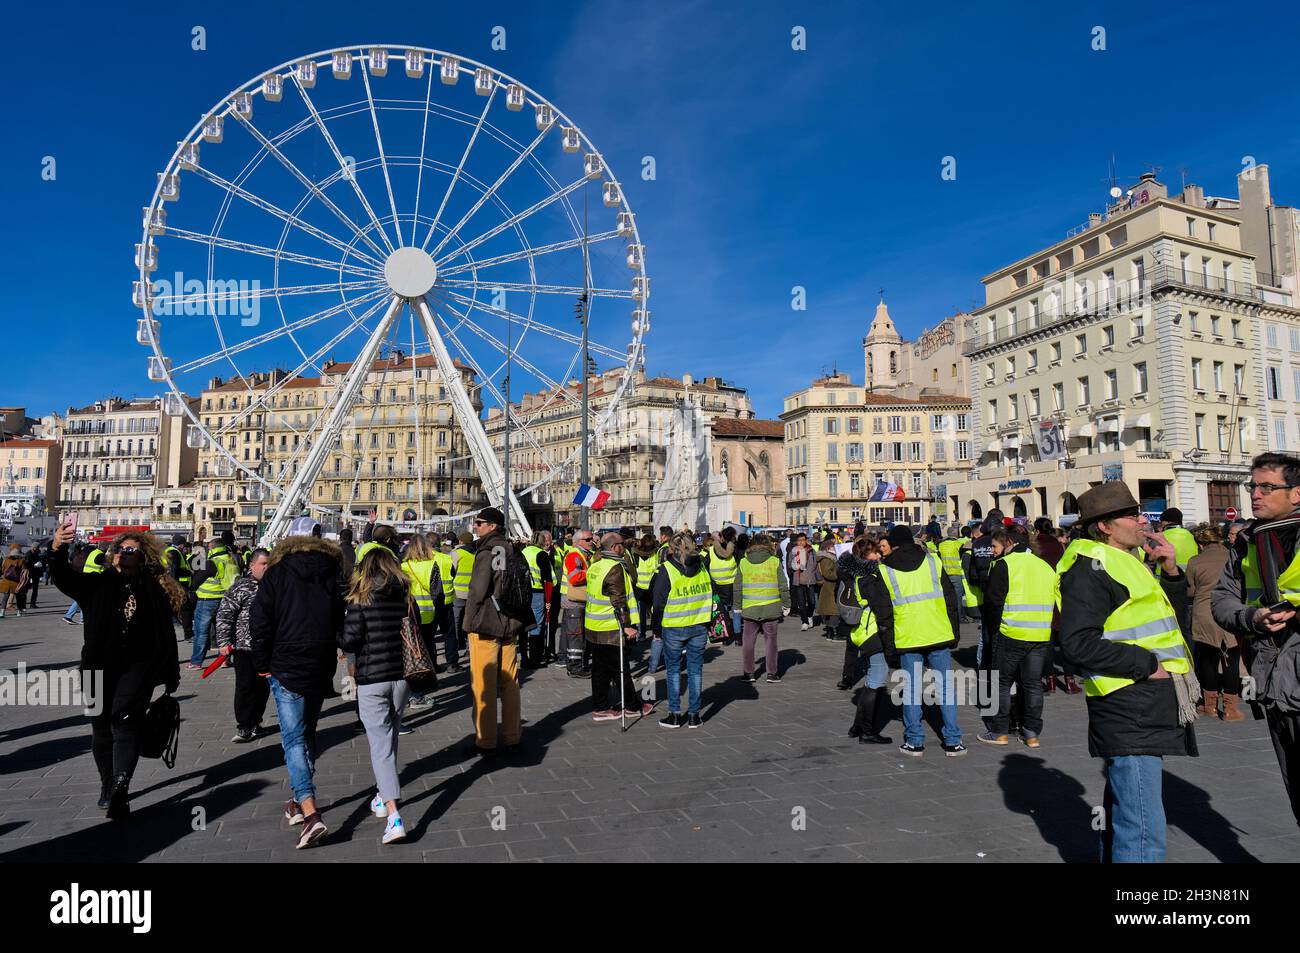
[49,524,185,820]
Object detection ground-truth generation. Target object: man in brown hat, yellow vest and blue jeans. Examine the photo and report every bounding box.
[1057,480,1199,863]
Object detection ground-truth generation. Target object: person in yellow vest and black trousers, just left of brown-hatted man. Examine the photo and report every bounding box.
[976,524,1057,748]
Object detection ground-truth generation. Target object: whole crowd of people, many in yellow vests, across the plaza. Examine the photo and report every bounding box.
[27,454,1300,862]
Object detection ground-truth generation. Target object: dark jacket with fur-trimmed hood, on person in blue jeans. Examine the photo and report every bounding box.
[248,536,343,698]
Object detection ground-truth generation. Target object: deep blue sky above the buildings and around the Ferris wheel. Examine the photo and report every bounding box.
[0,1,1300,416]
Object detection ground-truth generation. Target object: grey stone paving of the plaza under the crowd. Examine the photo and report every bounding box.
[0,603,1300,863]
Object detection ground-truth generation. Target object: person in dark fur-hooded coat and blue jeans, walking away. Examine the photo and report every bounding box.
[248,536,343,848]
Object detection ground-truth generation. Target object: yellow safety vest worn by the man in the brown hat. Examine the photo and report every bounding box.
[1056,540,1192,697]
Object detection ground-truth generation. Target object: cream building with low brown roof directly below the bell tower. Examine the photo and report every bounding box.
[781,369,972,525]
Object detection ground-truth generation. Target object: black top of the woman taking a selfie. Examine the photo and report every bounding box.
[49,546,181,716]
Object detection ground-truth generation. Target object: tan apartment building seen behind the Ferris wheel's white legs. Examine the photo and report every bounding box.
[195,350,485,538]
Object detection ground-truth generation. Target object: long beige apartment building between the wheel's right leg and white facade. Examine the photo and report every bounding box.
[485,368,754,529]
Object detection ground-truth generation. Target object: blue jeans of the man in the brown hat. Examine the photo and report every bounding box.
[1101,754,1165,863]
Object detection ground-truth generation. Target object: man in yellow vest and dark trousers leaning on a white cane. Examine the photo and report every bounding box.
[585,532,654,722]
